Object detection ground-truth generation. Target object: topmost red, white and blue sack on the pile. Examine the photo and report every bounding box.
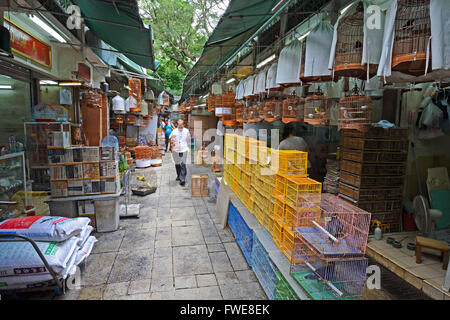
[0,216,91,241]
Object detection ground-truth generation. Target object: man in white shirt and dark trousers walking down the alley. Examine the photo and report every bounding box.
[169,119,191,186]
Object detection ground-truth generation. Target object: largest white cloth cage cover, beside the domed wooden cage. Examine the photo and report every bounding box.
[304,21,333,77]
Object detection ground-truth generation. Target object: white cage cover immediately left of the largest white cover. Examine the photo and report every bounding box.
[276,40,302,84]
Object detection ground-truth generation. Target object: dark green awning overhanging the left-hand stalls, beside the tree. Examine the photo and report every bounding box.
[76,0,156,70]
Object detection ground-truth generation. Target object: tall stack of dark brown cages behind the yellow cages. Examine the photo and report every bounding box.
[339,127,408,232]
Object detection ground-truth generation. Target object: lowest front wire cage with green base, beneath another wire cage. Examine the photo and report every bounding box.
[290,258,368,300]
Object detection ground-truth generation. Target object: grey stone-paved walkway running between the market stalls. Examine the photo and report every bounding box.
[45,154,267,300]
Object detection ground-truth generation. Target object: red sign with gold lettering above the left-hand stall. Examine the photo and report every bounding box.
[4,19,52,68]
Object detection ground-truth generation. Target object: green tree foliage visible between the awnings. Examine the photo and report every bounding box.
[139,0,228,95]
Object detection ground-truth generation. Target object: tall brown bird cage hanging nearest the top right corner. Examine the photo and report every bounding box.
[392,0,430,76]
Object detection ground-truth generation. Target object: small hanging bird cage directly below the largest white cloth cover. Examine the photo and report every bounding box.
[303,87,331,125]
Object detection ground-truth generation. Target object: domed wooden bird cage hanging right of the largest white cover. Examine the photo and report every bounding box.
[334,2,378,79]
